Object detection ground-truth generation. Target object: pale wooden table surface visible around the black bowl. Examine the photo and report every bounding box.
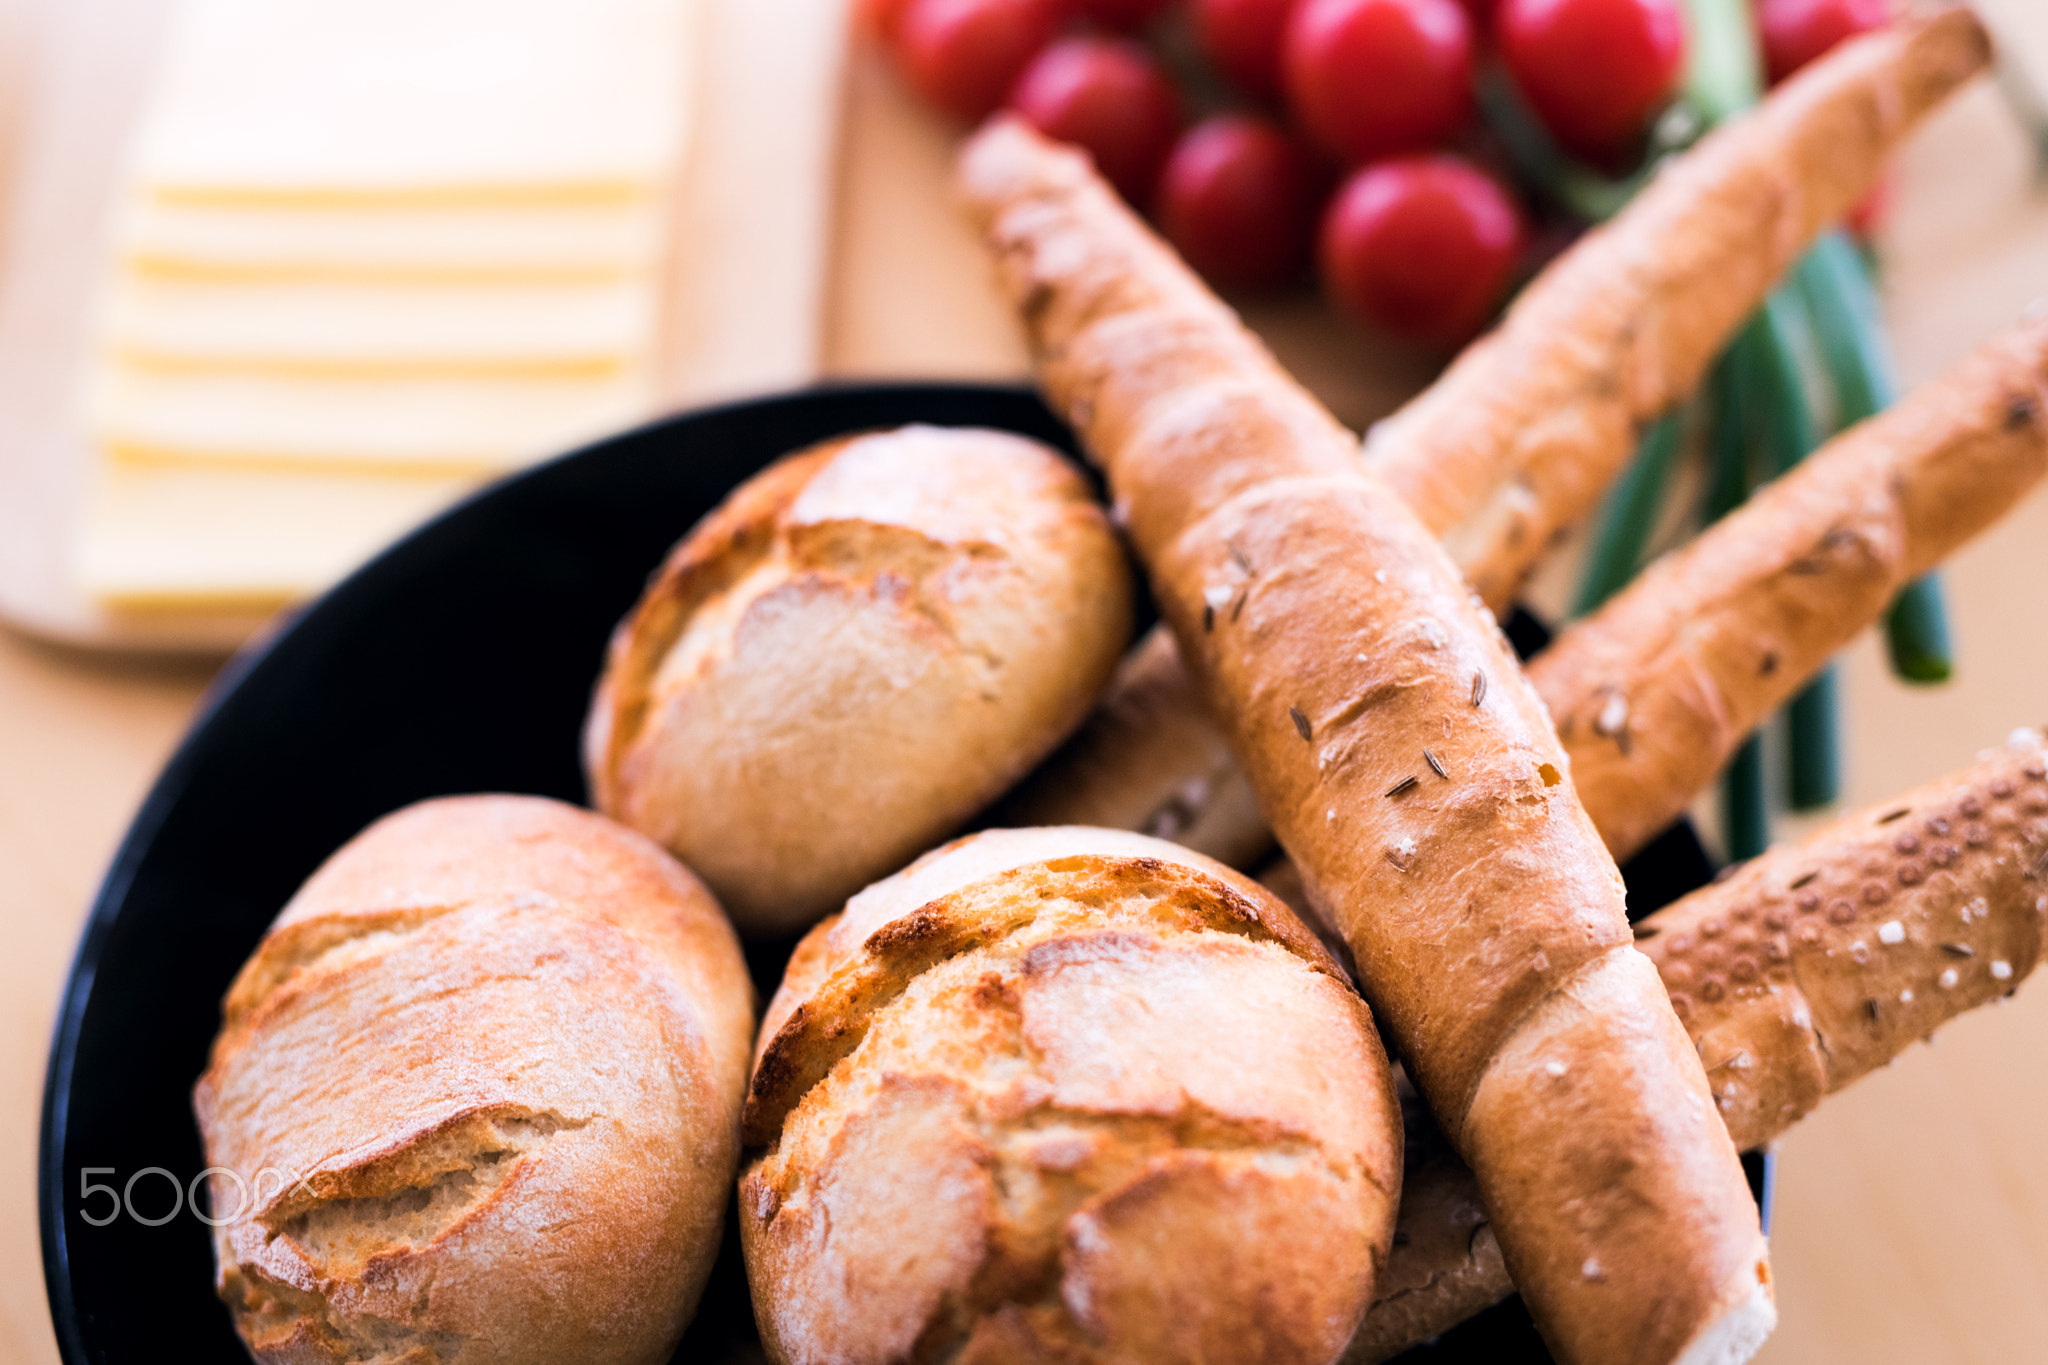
[0,0,2048,1365]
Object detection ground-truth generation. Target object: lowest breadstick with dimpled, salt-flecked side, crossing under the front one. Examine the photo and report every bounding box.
[1346,731,2048,1365]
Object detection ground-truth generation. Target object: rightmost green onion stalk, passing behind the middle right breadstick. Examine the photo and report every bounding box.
[1794,231,1956,684]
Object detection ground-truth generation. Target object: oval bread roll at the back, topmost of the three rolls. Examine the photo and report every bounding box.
[584,426,1133,933]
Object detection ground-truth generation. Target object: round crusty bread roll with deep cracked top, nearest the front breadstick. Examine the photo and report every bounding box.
[739,829,1401,1365]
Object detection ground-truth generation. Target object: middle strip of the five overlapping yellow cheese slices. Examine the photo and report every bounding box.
[106,278,657,375]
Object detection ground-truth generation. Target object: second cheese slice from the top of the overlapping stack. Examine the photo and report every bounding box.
[119,199,670,284]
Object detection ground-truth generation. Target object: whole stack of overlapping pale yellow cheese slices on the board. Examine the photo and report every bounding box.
[78,0,696,612]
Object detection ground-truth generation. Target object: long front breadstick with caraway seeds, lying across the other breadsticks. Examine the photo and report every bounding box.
[963,123,1776,1365]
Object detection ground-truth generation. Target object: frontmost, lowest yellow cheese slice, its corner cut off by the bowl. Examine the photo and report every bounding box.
[76,465,475,612]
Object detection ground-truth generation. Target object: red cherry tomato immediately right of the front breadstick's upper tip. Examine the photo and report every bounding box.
[1010,37,1180,207]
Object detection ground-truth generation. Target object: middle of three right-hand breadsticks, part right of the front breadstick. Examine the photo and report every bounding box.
[1530,319,2048,860]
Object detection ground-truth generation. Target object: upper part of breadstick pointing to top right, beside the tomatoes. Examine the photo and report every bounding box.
[1366,8,1991,610]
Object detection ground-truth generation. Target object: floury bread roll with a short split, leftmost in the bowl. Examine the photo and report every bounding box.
[193,796,754,1365]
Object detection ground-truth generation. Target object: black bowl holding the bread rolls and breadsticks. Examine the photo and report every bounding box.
[39,385,1761,1365]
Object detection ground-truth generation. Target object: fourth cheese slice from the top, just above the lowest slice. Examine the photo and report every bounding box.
[90,364,653,473]
